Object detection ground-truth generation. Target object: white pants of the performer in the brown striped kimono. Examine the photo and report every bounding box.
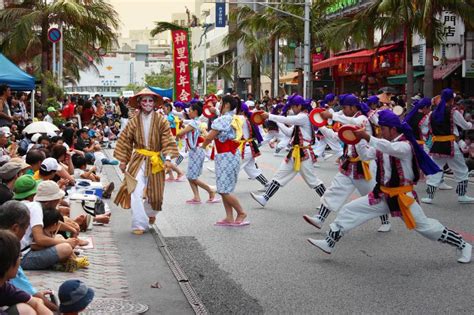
[131,167,156,231]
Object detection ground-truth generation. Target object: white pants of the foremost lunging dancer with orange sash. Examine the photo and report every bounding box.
[330,194,444,241]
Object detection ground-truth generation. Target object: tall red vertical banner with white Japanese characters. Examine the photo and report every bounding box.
[171,30,191,102]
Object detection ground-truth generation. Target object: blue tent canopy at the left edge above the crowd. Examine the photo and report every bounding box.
[0,54,35,91]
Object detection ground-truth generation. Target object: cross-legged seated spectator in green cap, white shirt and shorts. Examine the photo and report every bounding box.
[13,175,79,270]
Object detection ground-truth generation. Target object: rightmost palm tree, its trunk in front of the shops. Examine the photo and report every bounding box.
[414,0,474,97]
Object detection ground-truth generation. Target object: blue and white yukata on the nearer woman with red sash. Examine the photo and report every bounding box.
[211,113,240,194]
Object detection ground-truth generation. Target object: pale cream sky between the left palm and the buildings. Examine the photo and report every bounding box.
[109,0,194,35]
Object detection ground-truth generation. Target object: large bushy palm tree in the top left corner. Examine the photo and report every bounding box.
[0,0,119,102]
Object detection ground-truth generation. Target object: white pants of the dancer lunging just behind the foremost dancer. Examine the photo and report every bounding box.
[321,172,375,211]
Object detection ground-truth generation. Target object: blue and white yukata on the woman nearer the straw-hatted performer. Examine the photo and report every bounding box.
[186,119,206,179]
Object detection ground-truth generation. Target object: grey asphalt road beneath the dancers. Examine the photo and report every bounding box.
[153,148,474,314]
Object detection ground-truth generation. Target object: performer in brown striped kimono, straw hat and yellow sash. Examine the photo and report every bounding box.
[114,89,178,235]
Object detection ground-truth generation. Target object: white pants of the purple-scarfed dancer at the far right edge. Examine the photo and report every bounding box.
[426,142,469,187]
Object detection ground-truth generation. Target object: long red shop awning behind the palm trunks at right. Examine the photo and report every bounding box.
[313,43,400,71]
